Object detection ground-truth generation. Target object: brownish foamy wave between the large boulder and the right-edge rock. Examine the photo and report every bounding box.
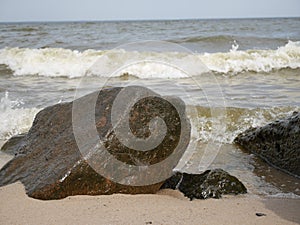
[190,106,300,144]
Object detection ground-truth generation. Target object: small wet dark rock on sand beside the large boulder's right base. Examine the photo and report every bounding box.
[161,169,247,200]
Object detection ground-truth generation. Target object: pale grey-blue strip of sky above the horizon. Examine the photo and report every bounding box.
[0,0,300,22]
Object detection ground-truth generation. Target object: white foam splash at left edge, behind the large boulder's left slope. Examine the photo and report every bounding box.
[0,92,39,140]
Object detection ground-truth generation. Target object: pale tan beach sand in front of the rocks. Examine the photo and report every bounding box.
[0,152,300,225]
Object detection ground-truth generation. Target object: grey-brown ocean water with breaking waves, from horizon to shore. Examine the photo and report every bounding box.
[0,18,300,197]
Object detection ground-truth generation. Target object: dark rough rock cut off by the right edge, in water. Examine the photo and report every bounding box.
[234,112,300,177]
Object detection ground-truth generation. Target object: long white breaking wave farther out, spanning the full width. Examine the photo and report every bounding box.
[0,41,300,78]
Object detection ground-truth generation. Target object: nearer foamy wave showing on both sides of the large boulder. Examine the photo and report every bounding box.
[0,89,300,144]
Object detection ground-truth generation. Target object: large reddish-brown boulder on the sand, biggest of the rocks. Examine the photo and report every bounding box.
[0,87,190,199]
